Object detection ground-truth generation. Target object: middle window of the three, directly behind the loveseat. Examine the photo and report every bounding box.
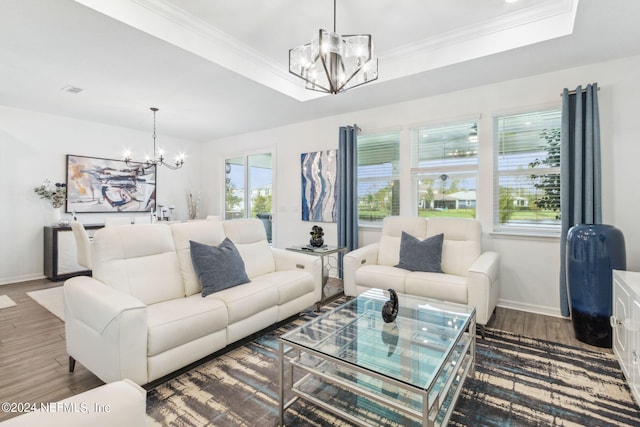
[411,120,478,218]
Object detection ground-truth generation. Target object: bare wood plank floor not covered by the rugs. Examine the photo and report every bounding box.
[0,279,611,421]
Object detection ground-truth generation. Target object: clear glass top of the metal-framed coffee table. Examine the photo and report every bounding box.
[281,289,475,390]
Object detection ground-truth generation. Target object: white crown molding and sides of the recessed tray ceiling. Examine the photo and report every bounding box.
[74,0,579,101]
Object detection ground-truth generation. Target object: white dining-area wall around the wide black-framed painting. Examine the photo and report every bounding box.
[0,106,201,286]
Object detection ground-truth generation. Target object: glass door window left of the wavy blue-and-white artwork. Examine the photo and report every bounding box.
[224,153,272,242]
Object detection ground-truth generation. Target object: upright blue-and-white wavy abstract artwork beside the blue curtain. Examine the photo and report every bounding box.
[300,150,338,222]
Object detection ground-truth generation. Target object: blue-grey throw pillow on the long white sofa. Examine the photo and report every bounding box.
[190,238,249,297]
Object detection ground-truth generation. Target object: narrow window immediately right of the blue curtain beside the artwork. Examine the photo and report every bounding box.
[358,132,400,225]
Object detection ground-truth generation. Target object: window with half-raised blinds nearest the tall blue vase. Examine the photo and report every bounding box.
[494,110,561,232]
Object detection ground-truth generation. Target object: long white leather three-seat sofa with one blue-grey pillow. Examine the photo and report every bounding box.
[64,219,322,384]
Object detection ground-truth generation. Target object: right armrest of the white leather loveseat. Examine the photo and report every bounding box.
[467,251,500,325]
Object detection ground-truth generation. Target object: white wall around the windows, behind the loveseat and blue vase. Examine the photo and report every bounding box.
[203,57,640,315]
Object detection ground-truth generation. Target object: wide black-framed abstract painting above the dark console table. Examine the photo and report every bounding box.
[67,154,156,212]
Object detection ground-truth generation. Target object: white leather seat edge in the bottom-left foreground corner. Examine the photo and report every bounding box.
[0,380,147,427]
